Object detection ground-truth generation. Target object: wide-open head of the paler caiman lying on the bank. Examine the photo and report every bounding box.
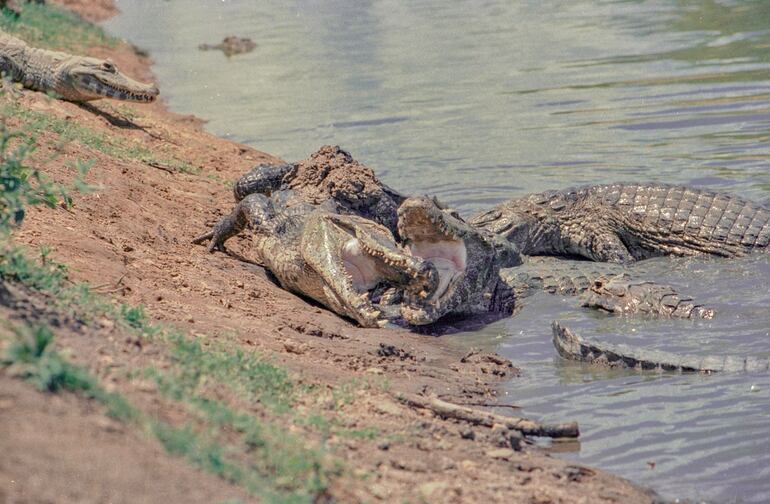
[300,212,439,327]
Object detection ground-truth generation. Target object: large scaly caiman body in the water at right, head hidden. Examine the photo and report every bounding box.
[469,184,770,263]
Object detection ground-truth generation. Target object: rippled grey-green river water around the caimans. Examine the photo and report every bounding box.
[106,0,770,502]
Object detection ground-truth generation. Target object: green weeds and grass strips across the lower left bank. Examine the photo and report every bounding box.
[0,121,342,502]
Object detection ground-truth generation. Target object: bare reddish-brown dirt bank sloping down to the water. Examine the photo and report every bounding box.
[0,1,653,503]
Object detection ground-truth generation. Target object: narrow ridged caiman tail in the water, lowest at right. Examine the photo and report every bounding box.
[552,321,770,373]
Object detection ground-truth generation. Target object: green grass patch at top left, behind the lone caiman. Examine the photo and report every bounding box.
[0,2,118,52]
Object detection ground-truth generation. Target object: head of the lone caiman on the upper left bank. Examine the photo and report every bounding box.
[63,58,160,103]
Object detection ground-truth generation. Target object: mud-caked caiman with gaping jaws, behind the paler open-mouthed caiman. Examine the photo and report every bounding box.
[225,146,521,325]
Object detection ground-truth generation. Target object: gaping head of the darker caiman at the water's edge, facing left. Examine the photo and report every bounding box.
[398,197,521,325]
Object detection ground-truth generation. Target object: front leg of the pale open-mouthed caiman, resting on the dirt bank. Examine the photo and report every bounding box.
[192,194,275,252]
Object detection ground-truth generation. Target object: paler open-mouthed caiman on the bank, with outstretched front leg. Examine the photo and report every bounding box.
[194,191,438,327]
